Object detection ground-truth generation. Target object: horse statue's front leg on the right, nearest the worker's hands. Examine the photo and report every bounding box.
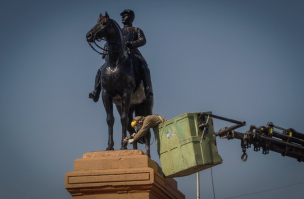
[120,87,132,149]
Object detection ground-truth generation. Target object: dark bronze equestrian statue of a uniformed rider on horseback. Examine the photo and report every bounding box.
[86,10,154,157]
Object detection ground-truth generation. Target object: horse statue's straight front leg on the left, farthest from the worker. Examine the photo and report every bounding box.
[102,90,114,150]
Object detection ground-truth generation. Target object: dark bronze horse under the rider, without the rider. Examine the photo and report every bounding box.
[86,12,153,157]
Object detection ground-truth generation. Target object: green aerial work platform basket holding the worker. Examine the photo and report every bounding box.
[153,112,222,178]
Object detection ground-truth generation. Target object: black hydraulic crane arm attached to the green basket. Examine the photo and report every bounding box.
[200,114,304,162]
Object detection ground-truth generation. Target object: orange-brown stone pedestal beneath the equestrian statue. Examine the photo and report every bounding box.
[65,150,185,199]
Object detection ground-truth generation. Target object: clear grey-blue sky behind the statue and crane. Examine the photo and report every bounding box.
[0,0,304,199]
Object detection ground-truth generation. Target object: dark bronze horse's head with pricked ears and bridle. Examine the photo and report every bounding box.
[86,12,113,43]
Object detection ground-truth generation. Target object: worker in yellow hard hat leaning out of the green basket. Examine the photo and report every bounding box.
[128,115,167,144]
